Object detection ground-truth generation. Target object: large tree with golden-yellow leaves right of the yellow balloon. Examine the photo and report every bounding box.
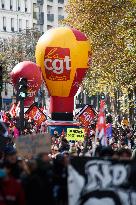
[63,0,136,94]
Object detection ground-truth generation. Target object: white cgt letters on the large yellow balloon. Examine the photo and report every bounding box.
[44,56,71,74]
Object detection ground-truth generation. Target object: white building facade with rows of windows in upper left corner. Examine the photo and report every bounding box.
[0,0,33,38]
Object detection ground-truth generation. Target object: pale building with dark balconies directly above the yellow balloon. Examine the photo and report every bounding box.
[33,0,67,33]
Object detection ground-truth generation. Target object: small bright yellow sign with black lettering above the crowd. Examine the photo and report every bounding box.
[67,128,85,142]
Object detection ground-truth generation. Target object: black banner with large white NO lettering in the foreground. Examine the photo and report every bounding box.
[68,157,136,205]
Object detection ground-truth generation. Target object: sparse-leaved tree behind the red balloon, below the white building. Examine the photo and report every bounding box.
[0,29,41,81]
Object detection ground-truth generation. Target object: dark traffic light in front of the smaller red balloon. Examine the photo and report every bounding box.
[18,78,27,98]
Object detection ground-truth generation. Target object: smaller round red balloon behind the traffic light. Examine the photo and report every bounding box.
[10,61,42,107]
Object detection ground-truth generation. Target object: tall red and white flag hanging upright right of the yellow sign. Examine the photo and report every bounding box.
[95,100,107,146]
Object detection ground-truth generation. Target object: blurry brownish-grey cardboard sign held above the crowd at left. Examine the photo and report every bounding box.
[15,133,51,156]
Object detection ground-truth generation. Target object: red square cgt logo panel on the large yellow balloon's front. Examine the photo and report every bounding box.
[44,47,71,81]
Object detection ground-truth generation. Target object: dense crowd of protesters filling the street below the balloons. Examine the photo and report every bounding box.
[0,111,136,205]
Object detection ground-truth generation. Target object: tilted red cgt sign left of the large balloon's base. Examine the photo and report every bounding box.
[26,104,47,125]
